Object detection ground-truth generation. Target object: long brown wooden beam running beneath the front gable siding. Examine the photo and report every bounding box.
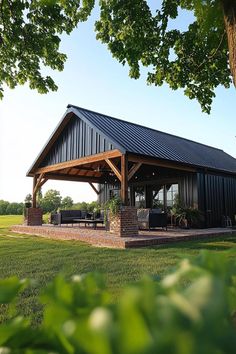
[35,149,121,174]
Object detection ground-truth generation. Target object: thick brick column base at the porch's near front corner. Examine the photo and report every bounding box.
[110,206,138,237]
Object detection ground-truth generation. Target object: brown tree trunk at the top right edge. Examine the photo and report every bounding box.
[221,0,236,86]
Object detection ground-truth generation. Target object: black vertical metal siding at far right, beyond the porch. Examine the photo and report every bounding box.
[198,173,236,227]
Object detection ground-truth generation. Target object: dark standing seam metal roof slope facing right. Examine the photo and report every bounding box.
[68,105,236,173]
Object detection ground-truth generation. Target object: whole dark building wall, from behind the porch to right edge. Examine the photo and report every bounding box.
[99,172,236,227]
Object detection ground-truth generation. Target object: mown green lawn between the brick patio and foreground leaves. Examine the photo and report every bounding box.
[0,216,236,322]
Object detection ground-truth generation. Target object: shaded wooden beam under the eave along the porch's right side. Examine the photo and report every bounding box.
[128,154,197,172]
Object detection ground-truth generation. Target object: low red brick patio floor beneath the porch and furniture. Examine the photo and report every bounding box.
[11,225,236,248]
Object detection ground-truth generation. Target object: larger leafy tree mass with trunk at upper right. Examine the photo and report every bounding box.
[96,0,236,113]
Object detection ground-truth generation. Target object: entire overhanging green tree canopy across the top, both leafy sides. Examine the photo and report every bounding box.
[0,0,236,113]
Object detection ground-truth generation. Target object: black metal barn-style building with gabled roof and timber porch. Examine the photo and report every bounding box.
[27,105,236,227]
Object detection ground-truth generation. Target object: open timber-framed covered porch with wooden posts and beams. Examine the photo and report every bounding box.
[28,149,197,237]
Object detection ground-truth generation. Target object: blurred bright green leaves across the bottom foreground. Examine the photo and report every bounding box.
[0,252,236,354]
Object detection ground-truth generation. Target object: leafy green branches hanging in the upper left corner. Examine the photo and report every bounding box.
[0,0,94,96]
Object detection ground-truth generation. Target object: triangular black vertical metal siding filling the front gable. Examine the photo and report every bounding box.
[40,116,115,167]
